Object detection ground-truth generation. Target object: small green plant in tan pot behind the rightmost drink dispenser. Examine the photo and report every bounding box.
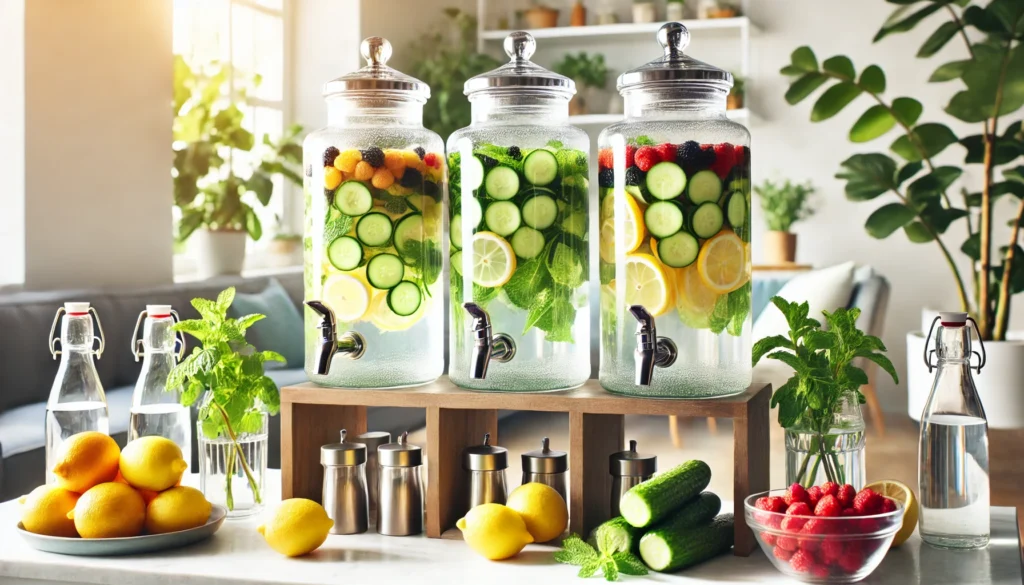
[754,179,814,264]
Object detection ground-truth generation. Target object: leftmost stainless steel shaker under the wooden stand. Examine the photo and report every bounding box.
[321,429,369,534]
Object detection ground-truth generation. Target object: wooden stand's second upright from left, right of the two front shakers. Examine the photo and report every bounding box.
[427,407,498,538]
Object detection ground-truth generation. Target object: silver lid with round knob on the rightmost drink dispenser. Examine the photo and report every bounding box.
[615,23,732,92]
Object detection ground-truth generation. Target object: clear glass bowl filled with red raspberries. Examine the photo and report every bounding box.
[743,482,903,583]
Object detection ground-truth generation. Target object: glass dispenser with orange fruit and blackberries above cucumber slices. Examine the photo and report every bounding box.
[303,37,445,388]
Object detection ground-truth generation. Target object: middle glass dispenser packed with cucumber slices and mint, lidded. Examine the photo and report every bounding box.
[447,32,590,391]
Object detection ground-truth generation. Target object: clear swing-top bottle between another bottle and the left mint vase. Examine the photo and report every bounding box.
[128,304,191,469]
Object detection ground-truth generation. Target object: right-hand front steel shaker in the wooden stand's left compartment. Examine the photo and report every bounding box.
[377,432,423,536]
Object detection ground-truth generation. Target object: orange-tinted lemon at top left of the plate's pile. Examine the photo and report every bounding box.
[52,430,121,494]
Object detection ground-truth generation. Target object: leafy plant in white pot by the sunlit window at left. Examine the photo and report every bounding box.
[171,55,302,278]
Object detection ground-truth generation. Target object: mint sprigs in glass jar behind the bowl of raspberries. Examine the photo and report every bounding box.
[753,296,899,489]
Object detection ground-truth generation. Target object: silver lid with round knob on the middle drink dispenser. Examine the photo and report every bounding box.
[463,31,575,99]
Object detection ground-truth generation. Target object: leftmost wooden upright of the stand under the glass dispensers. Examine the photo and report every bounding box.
[281,403,367,502]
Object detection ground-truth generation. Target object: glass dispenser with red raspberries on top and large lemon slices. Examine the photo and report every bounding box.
[598,23,752,398]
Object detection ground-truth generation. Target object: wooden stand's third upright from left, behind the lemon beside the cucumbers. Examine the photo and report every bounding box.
[569,412,626,538]
